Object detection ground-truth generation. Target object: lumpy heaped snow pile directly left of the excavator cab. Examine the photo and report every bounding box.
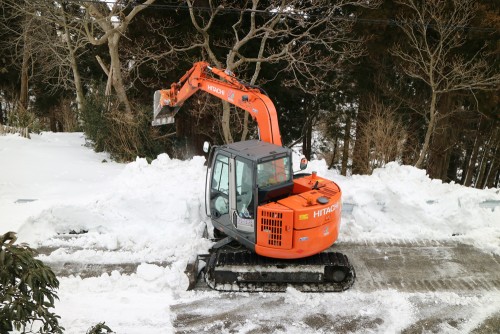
[15,150,209,263]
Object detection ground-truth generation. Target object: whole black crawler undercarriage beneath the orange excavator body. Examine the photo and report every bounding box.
[205,249,356,292]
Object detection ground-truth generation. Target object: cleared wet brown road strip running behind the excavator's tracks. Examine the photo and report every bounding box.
[37,239,500,292]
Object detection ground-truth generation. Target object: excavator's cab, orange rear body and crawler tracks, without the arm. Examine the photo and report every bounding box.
[200,140,355,291]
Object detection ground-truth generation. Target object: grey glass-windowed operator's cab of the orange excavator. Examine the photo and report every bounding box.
[206,140,293,249]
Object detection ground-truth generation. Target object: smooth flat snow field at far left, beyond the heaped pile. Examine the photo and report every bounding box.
[0,132,123,230]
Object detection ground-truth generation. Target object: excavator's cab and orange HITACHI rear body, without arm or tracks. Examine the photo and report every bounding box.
[205,140,348,259]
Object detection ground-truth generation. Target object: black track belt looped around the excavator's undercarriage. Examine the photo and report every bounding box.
[205,250,356,292]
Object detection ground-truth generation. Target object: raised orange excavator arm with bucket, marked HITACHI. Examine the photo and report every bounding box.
[152,62,282,146]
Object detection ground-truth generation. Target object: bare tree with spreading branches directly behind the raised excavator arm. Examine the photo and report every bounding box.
[150,0,379,143]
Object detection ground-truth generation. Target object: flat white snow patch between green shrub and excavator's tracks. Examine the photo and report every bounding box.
[56,265,178,334]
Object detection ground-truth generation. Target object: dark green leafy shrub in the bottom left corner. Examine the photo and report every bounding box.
[0,232,64,334]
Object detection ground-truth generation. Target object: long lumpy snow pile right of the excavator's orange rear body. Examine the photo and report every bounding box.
[302,161,500,254]
